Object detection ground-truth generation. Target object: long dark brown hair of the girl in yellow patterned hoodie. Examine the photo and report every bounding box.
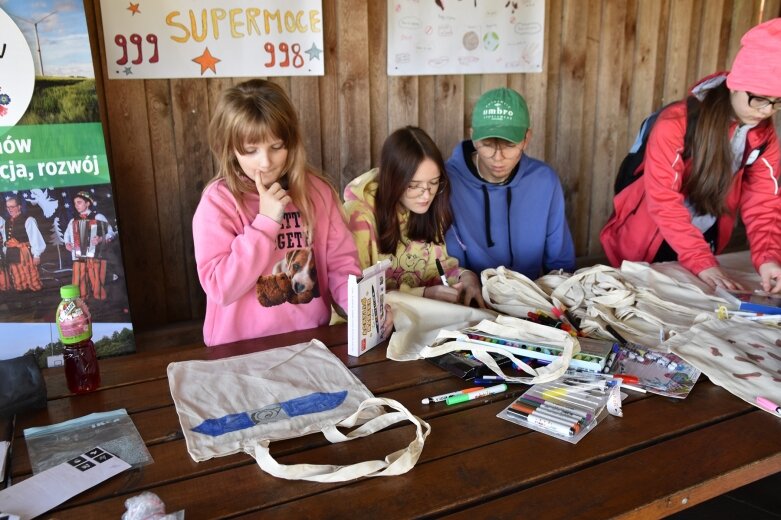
[375,126,453,254]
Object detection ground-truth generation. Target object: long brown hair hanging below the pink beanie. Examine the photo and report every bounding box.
[683,83,736,216]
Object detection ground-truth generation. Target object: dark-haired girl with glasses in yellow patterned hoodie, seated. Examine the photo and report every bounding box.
[344,126,484,307]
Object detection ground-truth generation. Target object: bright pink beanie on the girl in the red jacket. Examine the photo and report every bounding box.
[727,18,781,97]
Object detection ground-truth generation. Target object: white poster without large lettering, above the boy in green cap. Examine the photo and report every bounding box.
[388,0,545,76]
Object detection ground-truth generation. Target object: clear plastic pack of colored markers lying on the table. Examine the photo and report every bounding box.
[498,376,610,444]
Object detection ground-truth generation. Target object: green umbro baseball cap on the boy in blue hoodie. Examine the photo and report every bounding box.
[472,88,531,144]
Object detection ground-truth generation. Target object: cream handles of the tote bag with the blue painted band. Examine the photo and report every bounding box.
[254,397,431,482]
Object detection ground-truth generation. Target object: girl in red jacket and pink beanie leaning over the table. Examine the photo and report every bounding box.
[600,18,781,293]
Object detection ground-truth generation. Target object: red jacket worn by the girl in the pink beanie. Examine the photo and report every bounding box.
[599,73,781,274]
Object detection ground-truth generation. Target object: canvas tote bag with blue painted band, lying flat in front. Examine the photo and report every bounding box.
[168,340,431,482]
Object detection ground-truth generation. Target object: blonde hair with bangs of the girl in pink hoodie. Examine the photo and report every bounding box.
[207,79,328,238]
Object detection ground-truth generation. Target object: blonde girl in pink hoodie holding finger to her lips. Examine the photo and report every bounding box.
[193,79,361,346]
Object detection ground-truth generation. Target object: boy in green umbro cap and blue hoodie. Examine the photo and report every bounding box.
[445,88,575,280]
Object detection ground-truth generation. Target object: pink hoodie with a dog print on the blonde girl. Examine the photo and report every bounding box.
[193,176,361,346]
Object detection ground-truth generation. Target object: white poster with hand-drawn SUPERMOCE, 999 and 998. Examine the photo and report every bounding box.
[100,0,325,79]
